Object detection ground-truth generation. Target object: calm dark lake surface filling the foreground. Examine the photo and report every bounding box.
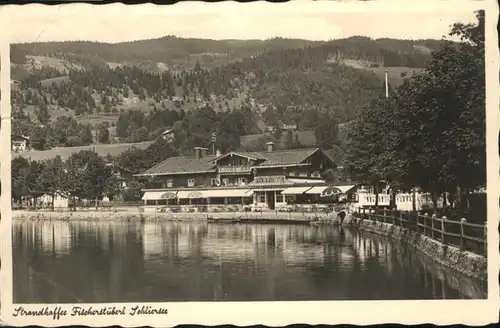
[13,221,487,303]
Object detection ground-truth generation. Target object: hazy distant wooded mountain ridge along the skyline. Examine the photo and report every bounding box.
[11,36,441,69]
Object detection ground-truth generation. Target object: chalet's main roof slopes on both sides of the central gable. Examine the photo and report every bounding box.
[139,148,332,175]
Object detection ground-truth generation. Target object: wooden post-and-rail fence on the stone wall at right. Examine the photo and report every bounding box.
[356,209,488,256]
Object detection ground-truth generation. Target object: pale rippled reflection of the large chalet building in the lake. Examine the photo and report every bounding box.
[143,222,364,265]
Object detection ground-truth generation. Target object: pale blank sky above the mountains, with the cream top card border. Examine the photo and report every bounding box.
[0,0,482,43]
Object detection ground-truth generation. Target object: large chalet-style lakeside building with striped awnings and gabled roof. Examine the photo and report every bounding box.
[137,142,335,211]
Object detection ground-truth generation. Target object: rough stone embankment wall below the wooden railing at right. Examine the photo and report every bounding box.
[343,215,488,281]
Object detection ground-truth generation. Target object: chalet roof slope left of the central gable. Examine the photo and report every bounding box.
[141,155,215,175]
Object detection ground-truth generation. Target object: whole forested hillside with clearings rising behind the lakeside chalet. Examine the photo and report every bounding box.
[11,37,440,157]
